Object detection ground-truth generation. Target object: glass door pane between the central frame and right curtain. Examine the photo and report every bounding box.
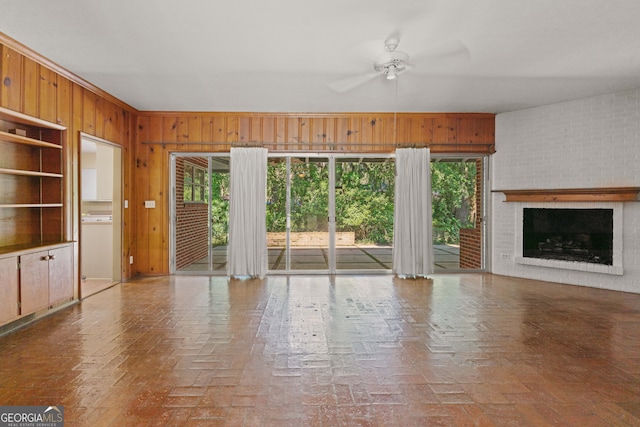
[335,158,395,270]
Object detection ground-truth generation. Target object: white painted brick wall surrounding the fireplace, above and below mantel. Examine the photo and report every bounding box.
[491,89,640,293]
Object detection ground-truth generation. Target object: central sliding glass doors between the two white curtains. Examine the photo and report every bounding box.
[267,155,394,273]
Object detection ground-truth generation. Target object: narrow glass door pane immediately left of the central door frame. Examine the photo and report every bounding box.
[289,157,329,270]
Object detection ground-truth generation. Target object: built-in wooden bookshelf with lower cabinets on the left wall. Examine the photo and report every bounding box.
[0,107,74,332]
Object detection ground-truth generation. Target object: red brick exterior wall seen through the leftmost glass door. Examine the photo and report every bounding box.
[176,157,209,270]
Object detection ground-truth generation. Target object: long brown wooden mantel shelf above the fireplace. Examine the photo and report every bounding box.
[492,187,640,202]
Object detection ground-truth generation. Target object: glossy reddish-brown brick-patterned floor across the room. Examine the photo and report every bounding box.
[0,274,640,427]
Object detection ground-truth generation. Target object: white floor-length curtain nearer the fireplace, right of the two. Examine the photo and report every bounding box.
[393,148,433,277]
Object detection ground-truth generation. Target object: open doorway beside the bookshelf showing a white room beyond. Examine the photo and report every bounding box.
[80,133,122,298]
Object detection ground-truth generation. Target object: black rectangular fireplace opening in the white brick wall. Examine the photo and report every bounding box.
[522,208,613,265]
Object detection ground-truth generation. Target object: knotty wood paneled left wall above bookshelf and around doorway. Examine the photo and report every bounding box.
[0,33,137,297]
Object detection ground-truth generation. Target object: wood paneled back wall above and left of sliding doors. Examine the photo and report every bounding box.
[135,112,495,274]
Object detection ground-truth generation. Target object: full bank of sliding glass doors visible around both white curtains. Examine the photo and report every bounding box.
[170,153,486,275]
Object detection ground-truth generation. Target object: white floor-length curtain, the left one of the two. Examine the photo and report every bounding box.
[227,147,268,277]
